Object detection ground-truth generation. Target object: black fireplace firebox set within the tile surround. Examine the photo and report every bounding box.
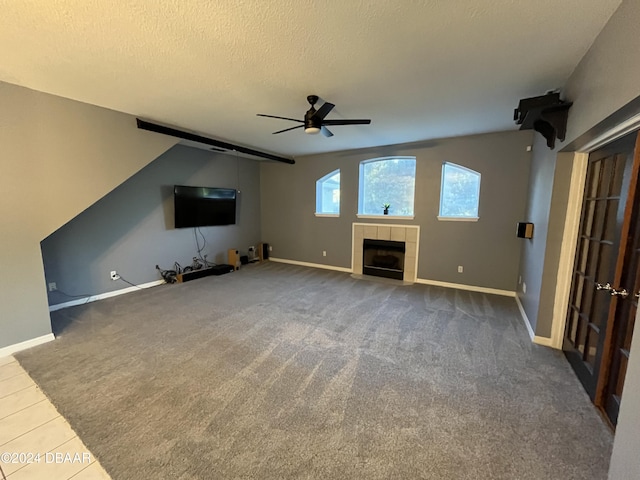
[362,238,405,280]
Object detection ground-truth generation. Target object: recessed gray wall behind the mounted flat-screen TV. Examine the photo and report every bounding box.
[41,146,260,304]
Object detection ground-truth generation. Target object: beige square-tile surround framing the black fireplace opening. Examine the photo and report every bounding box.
[351,223,420,282]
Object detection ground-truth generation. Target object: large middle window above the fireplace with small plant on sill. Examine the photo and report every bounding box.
[358,157,416,217]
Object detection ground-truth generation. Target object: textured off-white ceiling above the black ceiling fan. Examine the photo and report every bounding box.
[0,0,621,156]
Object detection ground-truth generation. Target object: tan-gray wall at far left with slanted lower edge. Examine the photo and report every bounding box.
[0,82,176,348]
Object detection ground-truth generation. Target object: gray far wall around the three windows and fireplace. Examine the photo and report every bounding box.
[261,131,532,291]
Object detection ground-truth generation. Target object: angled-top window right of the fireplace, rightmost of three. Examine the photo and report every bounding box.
[438,162,480,221]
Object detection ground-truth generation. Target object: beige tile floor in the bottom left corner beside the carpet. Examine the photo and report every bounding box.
[0,356,110,480]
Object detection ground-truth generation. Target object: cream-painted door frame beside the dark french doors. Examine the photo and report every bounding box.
[545,114,640,350]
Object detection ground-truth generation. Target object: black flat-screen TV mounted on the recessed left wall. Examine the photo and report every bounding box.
[173,185,236,228]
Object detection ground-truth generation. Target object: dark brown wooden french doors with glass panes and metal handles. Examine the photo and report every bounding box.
[563,129,640,425]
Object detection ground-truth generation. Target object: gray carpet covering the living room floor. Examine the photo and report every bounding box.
[16,262,612,480]
